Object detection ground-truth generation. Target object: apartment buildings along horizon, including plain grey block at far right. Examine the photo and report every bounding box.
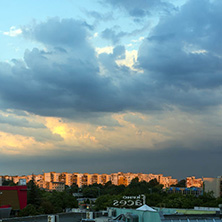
[0,172,219,197]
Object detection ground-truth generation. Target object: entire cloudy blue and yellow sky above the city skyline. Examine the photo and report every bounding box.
[0,0,222,178]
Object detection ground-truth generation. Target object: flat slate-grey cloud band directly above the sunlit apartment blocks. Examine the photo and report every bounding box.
[0,146,222,179]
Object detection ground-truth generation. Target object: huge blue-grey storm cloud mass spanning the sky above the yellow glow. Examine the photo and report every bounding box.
[0,0,222,118]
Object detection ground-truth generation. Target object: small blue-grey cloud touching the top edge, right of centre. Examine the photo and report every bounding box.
[105,0,175,18]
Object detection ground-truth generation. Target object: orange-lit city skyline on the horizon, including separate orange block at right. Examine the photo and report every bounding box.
[0,171,206,192]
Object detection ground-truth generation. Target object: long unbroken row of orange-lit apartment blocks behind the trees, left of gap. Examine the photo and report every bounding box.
[2,172,178,189]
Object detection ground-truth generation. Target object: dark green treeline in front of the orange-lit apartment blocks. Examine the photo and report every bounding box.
[20,178,222,216]
